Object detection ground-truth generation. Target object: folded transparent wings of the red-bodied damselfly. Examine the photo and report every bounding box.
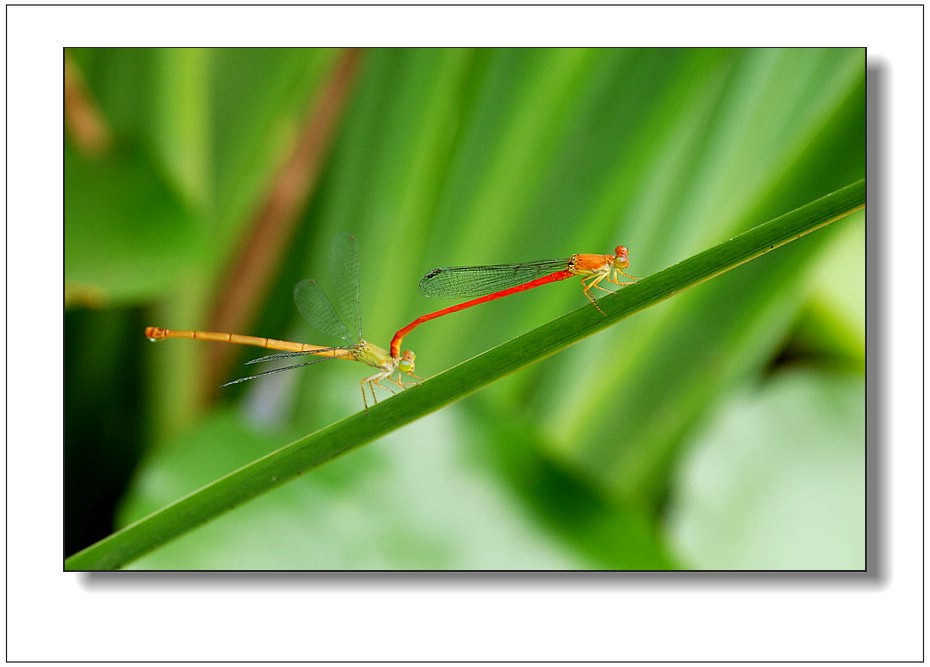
[420,259,571,297]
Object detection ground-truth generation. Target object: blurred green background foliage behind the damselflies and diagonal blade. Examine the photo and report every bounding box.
[65,49,865,569]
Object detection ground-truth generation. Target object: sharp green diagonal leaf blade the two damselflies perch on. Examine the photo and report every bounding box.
[65,181,865,570]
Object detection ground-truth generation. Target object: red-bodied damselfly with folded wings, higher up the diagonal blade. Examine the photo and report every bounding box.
[391,245,636,357]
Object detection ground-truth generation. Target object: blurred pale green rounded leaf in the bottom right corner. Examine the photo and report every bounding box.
[668,370,865,570]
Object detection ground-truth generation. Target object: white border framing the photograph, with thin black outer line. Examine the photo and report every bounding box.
[4,5,924,661]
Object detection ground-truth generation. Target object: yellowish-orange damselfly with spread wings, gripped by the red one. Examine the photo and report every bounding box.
[145,234,416,409]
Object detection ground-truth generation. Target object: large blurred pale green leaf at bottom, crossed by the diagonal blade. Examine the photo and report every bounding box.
[122,412,590,569]
